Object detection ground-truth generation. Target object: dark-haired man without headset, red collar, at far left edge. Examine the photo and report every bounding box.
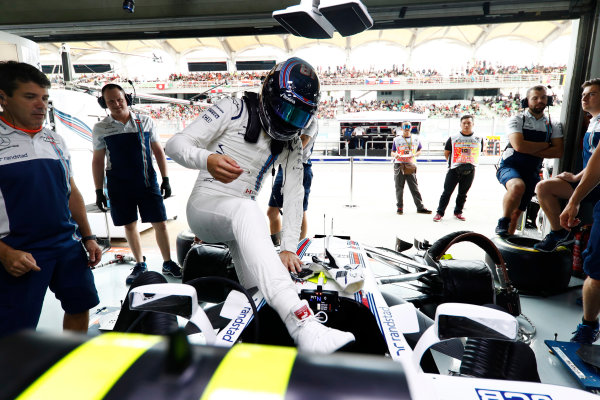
[0,61,102,336]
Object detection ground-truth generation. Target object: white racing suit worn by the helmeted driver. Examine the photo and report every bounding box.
[165,98,353,352]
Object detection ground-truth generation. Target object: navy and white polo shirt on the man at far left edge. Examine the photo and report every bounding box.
[0,120,81,254]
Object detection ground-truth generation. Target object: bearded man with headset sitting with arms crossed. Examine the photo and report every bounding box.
[496,85,563,237]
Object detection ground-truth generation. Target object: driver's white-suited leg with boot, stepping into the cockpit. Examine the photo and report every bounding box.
[187,196,354,353]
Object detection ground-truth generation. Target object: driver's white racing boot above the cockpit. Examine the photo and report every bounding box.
[284,300,355,354]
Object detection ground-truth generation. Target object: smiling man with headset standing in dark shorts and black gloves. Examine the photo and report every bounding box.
[92,83,181,285]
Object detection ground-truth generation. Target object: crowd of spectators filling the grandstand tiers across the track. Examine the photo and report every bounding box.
[44,61,566,120]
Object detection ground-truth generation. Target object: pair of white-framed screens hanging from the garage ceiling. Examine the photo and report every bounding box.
[273,0,373,39]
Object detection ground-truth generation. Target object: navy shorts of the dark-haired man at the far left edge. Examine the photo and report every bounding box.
[0,241,100,336]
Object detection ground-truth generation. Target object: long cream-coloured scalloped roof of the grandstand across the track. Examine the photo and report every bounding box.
[40,21,572,65]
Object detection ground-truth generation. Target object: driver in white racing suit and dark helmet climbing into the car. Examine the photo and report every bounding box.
[166,58,354,353]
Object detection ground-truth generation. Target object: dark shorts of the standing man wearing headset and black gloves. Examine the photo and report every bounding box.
[107,180,167,226]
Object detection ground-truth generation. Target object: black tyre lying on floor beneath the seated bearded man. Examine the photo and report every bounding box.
[486,236,573,296]
